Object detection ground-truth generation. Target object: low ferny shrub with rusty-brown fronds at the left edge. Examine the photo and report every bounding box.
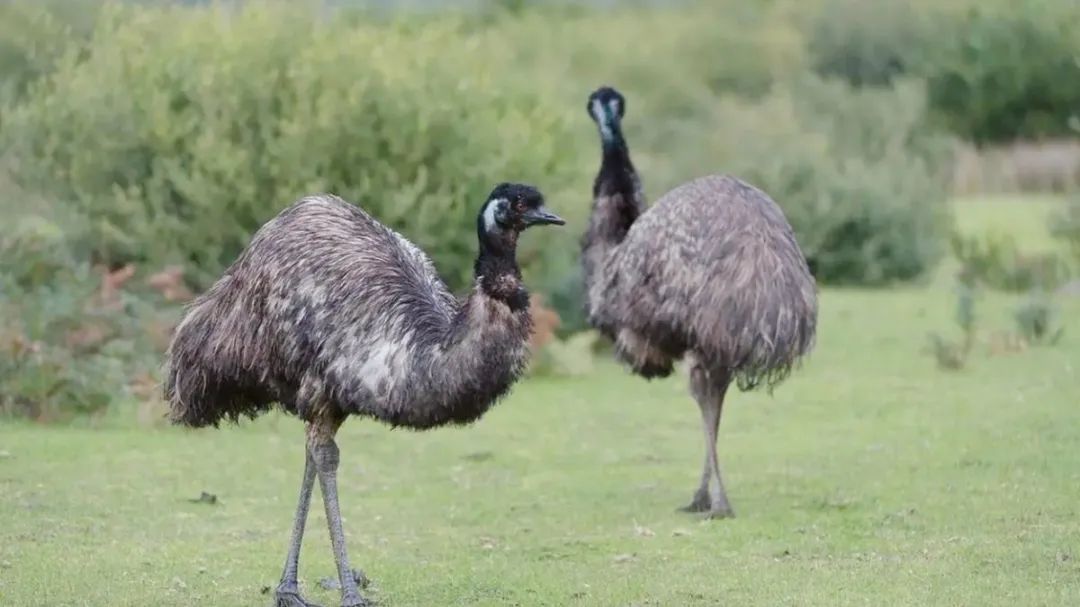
[0,254,178,420]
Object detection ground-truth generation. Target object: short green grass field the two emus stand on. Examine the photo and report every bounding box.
[0,196,1080,607]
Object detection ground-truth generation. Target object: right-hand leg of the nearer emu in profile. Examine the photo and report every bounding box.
[308,418,368,607]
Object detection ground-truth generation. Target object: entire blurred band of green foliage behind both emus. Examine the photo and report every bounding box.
[0,0,1080,417]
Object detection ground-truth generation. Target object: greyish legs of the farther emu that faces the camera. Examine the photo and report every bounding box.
[681,365,735,518]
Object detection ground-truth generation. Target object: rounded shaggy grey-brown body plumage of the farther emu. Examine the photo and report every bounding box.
[608,176,816,386]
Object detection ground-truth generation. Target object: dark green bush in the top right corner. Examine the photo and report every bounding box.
[916,0,1080,143]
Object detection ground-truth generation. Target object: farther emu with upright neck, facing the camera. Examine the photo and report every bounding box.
[582,87,818,517]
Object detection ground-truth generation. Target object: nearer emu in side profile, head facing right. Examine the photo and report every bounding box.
[164,184,563,607]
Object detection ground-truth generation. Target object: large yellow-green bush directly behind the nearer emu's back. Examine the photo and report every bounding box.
[4,5,577,285]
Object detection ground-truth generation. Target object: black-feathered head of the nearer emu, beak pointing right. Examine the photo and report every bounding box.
[476,184,566,244]
